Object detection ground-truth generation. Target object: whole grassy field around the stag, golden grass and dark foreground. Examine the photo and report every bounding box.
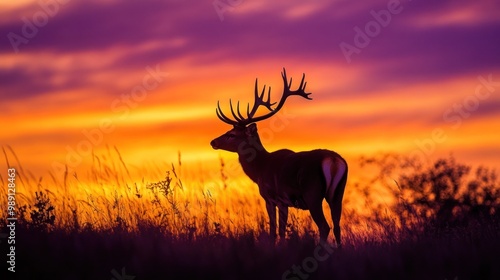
[0,147,500,279]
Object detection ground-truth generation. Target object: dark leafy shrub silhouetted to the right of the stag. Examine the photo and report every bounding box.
[395,157,500,227]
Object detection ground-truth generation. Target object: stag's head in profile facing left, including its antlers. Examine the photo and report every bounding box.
[210,68,311,153]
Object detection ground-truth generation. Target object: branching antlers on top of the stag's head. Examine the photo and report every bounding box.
[215,68,312,126]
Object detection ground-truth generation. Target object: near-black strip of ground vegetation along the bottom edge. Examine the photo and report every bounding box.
[2,219,500,280]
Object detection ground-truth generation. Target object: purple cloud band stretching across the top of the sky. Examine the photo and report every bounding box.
[0,0,500,103]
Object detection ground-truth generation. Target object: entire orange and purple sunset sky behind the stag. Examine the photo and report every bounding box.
[0,0,500,178]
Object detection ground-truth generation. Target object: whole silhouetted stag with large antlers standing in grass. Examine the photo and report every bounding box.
[210,68,347,246]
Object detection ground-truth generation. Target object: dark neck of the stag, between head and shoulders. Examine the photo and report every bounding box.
[238,135,269,183]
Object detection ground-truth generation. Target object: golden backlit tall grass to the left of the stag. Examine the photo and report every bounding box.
[0,148,324,237]
